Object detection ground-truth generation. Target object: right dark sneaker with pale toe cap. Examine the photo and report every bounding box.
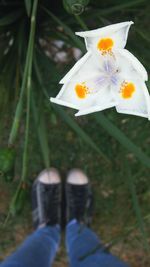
[66,169,93,225]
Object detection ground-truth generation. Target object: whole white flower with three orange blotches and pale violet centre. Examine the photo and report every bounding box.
[51,22,150,118]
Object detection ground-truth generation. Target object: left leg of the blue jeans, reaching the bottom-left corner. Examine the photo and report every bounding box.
[0,226,60,267]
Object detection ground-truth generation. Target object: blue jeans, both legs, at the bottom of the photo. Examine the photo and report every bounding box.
[0,220,128,267]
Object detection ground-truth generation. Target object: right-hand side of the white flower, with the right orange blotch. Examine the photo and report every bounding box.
[111,50,150,120]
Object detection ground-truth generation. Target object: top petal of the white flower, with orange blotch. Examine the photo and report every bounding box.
[76,21,133,52]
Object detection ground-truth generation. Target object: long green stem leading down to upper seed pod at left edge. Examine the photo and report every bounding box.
[8,0,38,145]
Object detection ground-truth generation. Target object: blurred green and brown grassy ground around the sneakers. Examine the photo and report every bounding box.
[0,112,150,267]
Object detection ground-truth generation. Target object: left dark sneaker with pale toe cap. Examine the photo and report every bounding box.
[32,171,61,228]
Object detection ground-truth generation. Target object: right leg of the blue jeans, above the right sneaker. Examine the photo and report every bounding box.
[66,220,128,267]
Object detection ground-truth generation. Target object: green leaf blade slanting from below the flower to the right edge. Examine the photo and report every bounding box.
[94,112,150,168]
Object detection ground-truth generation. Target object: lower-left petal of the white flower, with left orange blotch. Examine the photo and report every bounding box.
[50,76,115,110]
